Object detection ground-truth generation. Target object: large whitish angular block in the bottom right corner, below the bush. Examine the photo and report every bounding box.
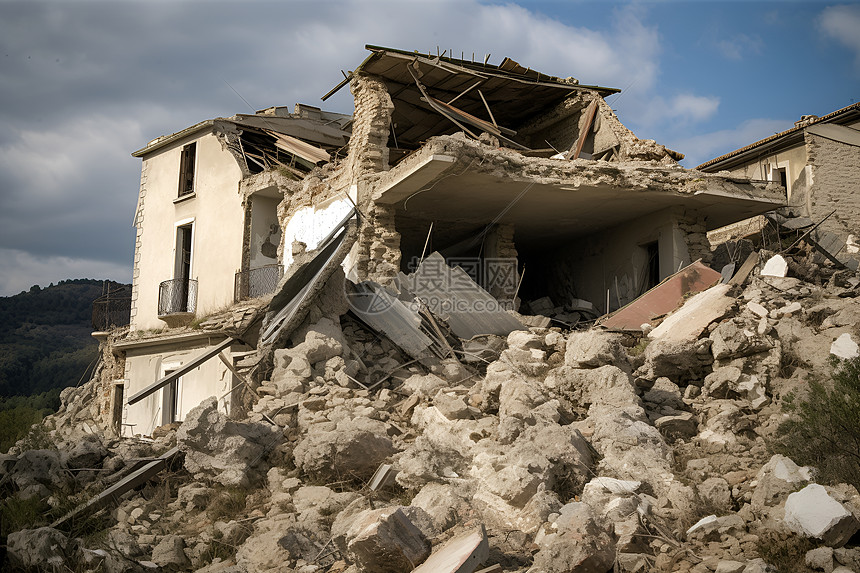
[785,483,860,547]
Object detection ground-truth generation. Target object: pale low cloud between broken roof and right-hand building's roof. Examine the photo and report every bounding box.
[667,119,792,168]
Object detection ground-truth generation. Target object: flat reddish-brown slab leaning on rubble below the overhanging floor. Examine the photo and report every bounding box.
[599,261,722,330]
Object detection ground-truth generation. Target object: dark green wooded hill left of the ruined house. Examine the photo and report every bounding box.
[0,279,129,398]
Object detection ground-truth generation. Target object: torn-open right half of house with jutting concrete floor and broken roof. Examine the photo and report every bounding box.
[312,46,785,313]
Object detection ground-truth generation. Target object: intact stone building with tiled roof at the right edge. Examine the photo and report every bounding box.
[696,103,860,242]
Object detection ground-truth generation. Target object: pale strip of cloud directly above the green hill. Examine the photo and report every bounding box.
[0,248,131,296]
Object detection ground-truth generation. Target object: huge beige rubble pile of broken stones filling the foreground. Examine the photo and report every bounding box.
[0,250,860,573]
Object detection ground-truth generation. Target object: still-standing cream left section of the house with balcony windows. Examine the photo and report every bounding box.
[113,106,351,435]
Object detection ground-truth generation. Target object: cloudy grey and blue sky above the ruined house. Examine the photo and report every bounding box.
[0,0,860,296]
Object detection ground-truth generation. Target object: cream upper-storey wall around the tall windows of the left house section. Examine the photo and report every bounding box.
[131,133,244,330]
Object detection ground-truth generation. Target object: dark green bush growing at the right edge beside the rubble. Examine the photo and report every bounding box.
[773,357,860,489]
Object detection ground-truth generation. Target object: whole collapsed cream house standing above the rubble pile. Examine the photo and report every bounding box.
[111,46,785,435]
